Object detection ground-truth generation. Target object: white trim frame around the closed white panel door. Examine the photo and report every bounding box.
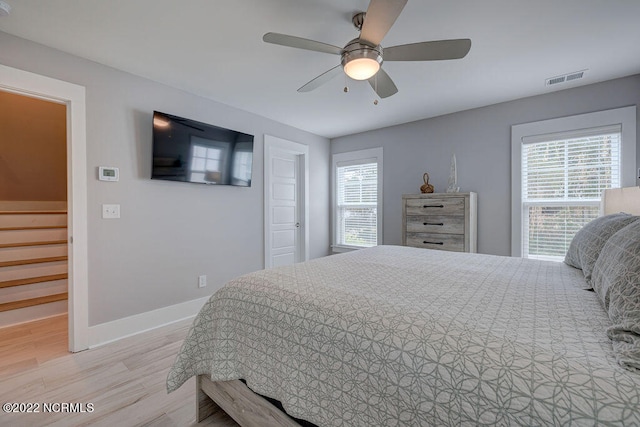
[264,134,309,268]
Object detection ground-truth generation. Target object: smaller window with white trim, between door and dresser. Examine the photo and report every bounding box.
[333,148,382,251]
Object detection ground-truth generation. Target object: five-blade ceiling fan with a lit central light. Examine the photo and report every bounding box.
[262,0,471,98]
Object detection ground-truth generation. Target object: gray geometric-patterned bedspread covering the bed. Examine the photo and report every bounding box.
[167,246,640,426]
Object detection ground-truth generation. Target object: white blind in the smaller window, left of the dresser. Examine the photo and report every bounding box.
[336,159,378,247]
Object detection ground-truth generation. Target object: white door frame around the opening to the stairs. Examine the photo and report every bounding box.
[0,64,89,352]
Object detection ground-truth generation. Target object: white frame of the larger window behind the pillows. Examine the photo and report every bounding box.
[511,105,636,257]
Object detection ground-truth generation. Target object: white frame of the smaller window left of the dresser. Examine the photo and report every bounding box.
[331,147,383,253]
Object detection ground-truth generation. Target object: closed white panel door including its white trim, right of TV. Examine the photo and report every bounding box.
[265,135,308,268]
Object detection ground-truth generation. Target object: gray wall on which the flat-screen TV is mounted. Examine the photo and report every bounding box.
[0,32,330,326]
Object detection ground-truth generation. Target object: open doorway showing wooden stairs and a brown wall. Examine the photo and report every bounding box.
[0,91,68,334]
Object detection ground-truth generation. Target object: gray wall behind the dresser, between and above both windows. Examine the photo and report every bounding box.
[331,75,640,255]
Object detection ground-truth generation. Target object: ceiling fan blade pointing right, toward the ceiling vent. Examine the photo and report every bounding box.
[384,39,471,61]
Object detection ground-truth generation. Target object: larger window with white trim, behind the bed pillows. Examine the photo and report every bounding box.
[512,107,635,261]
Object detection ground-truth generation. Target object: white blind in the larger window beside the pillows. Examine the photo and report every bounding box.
[521,125,621,261]
